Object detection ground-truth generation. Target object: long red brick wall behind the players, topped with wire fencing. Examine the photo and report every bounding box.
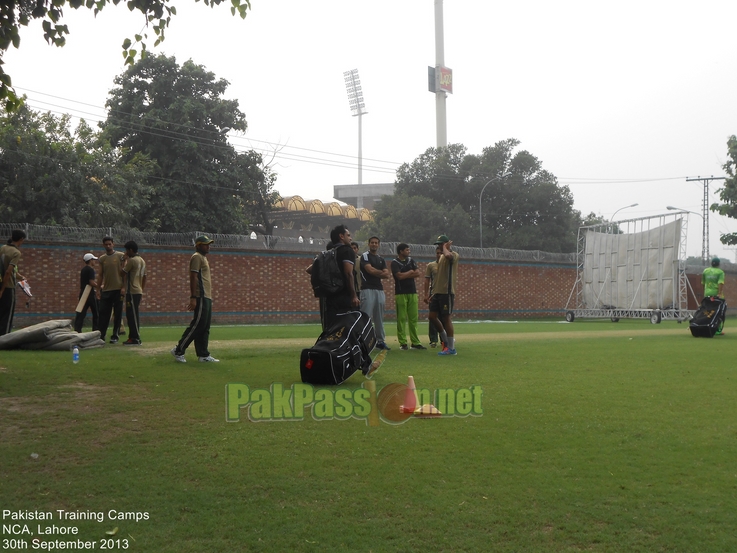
[10,243,737,328]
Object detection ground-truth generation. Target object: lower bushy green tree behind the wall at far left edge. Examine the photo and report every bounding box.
[0,104,153,227]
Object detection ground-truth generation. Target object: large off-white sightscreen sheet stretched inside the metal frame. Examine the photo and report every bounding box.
[583,219,681,309]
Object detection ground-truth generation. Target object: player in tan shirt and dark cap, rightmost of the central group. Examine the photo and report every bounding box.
[430,234,459,355]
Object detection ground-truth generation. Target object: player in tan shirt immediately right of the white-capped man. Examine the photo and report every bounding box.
[97,236,125,344]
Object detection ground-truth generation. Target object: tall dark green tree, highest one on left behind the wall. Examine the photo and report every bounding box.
[102,54,274,233]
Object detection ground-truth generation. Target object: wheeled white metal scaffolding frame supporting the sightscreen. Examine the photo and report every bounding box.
[566,211,694,324]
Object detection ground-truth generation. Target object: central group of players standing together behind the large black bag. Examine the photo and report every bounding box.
[314,225,459,355]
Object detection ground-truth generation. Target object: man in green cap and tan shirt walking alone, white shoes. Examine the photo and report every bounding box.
[171,236,220,363]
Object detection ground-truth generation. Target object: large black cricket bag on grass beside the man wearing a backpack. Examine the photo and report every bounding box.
[299,311,376,384]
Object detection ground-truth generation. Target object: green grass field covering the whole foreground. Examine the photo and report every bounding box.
[0,320,737,552]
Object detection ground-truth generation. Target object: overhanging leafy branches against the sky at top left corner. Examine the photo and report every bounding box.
[0,0,251,110]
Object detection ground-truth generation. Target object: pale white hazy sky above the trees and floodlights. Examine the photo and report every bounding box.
[5,0,737,260]
